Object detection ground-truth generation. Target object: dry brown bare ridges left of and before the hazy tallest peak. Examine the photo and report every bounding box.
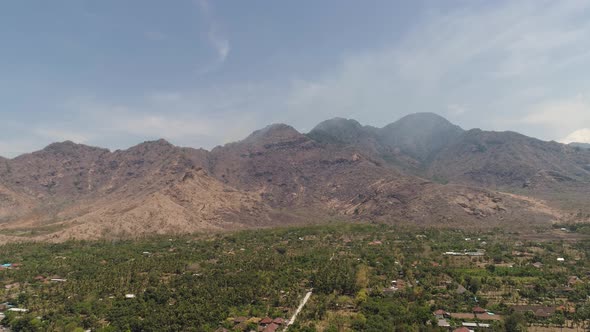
[0,116,584,241]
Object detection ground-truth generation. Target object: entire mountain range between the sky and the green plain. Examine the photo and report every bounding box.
[0,113,590,242]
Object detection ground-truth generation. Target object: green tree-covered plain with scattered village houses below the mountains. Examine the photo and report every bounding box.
[0,225,590,332]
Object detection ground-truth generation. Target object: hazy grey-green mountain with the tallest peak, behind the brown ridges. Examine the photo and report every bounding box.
[309,113,590,195]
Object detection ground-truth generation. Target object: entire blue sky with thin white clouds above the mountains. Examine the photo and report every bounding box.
[0,0,590,157]
